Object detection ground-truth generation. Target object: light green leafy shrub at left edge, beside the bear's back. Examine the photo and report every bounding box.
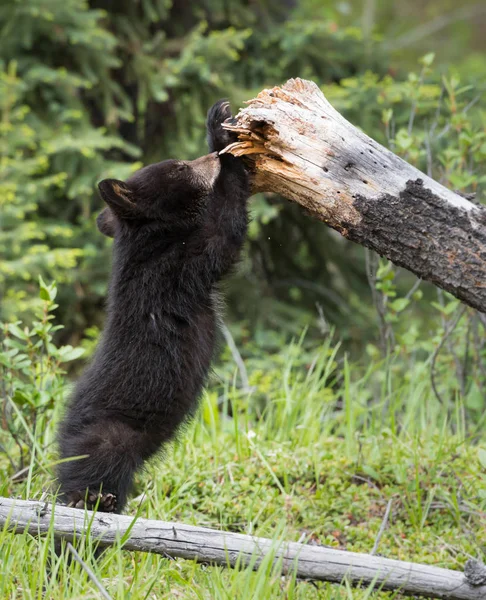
[0,278,84,471]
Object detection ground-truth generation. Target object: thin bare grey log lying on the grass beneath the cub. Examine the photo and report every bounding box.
[0,498,486,600]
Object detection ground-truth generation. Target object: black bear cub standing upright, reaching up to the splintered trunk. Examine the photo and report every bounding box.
[58,101,250,512]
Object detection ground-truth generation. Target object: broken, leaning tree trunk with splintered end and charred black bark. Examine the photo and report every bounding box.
[224,79,486,312]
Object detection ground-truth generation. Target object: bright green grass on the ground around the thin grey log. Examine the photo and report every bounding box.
[0,339,486,600]
